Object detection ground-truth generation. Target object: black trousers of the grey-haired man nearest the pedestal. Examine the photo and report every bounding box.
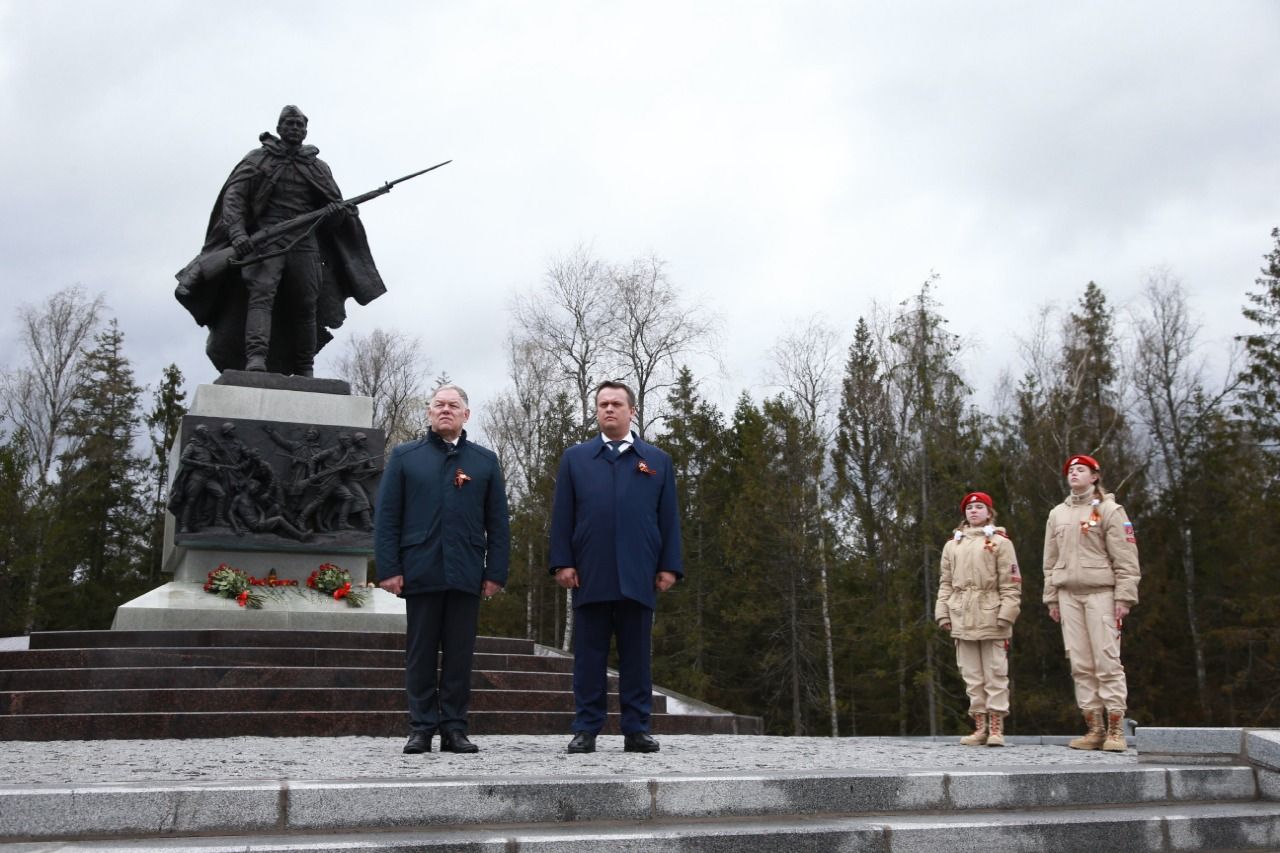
[404,589,480,734]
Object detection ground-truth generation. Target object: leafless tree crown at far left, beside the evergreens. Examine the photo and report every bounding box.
[0,287,104,484]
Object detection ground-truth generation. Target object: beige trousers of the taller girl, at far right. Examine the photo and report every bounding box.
[1057,589,1129,711]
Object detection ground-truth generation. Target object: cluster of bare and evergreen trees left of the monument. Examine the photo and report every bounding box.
[0,287,186,635]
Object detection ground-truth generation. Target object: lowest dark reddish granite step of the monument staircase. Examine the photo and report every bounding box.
[0,694,760,740]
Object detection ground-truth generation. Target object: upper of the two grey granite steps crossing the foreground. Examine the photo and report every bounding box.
[0,766,1258,841]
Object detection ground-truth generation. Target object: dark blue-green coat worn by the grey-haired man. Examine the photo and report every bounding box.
[374,432,511,596]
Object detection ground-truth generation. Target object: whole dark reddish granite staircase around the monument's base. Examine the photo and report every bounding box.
[0,629,762,740]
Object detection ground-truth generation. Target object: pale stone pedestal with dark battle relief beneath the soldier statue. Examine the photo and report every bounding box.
[111,371,404,630]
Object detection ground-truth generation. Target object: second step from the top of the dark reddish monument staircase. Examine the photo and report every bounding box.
[0,647,573,672]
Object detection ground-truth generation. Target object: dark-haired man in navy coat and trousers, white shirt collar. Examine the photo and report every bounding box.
[550,382,682,753]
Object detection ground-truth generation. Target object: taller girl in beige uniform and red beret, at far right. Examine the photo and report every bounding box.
[1044,456,1142,752]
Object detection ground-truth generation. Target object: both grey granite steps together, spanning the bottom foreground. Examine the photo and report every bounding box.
[0,766,1280,853]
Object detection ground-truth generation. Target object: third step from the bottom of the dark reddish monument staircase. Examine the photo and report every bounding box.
[0,666,591,692]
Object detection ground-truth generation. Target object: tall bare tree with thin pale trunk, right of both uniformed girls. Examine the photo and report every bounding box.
[1134,270,1238,720]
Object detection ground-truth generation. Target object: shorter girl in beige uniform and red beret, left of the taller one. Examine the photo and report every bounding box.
[933,492,1023,747]
